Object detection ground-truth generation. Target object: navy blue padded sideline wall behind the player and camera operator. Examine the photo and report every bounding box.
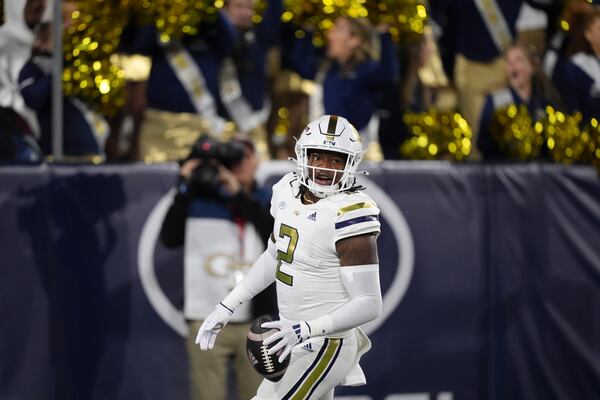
[0,162,600,400]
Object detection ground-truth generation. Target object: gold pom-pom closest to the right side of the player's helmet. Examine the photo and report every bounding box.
[400,109,473,161]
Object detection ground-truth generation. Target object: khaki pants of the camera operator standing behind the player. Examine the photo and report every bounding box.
[187,321,262,400]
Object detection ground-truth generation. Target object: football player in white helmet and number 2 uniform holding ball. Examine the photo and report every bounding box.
[196,115,382,400]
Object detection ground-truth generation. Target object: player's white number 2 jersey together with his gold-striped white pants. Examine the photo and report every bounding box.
[254,173,381,400]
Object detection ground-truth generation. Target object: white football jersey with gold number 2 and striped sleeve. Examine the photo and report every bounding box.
[271,173,381,321]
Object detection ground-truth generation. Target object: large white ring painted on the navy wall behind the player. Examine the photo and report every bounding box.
[138,162,414,337]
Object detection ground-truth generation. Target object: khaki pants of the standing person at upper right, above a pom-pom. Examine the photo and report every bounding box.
[454,54,506,158]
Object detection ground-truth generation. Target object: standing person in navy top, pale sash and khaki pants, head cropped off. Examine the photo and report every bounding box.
[430,0,554,159]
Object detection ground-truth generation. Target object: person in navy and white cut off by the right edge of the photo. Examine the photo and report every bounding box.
[566,8,600,125]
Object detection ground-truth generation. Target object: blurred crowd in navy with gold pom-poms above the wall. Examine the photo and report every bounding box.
[0,0,600,162]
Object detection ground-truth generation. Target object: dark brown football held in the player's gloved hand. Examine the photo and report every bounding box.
[246,316,291,382]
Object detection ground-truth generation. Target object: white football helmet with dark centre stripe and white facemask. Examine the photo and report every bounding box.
[296,115,363,198]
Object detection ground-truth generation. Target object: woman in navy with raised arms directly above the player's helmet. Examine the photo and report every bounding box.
[292,17,397,153]
